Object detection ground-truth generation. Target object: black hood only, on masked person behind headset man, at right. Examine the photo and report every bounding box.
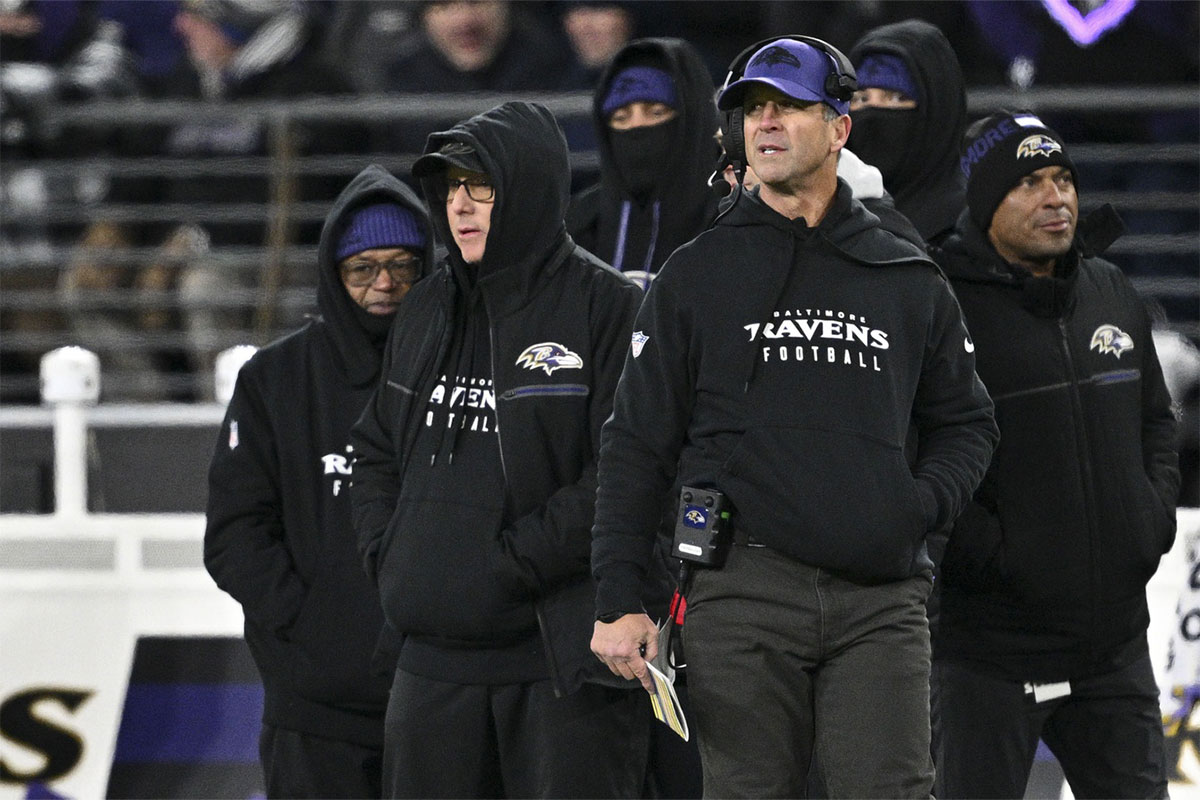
[850,19,967,240]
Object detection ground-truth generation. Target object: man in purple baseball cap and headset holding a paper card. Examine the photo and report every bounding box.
[592,37,997,798]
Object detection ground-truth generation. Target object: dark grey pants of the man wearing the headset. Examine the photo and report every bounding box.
[683,546,934,798]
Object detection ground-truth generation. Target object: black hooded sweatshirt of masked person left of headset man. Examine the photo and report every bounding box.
[566,38,720,284]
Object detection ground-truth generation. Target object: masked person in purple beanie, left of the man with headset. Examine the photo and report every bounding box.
[566,38,720,285]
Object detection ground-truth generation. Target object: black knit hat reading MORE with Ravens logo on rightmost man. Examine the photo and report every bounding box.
[959,112,1076,230]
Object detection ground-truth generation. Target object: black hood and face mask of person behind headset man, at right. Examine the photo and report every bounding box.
[846,19,967,243]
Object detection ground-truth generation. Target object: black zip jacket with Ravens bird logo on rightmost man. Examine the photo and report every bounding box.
[934,208,1180,681]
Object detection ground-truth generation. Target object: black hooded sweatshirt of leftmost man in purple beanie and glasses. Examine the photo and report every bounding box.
[204,166,433,747]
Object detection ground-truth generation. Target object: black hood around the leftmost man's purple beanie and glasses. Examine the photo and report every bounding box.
[317,164,433,386]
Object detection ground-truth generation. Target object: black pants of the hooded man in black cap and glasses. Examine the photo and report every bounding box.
[384,669,658,798]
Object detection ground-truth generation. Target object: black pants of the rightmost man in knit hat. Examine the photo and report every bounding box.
[932,655,1166,798]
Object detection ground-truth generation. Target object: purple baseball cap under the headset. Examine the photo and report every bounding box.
[716,38,850,114]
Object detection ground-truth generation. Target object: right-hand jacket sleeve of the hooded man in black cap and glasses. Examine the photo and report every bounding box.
[500,272,642,590]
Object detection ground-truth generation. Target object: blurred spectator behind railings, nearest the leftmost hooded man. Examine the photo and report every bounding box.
[60,0,349,399]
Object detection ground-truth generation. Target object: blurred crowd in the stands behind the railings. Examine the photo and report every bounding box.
[0,0,1200,402]
